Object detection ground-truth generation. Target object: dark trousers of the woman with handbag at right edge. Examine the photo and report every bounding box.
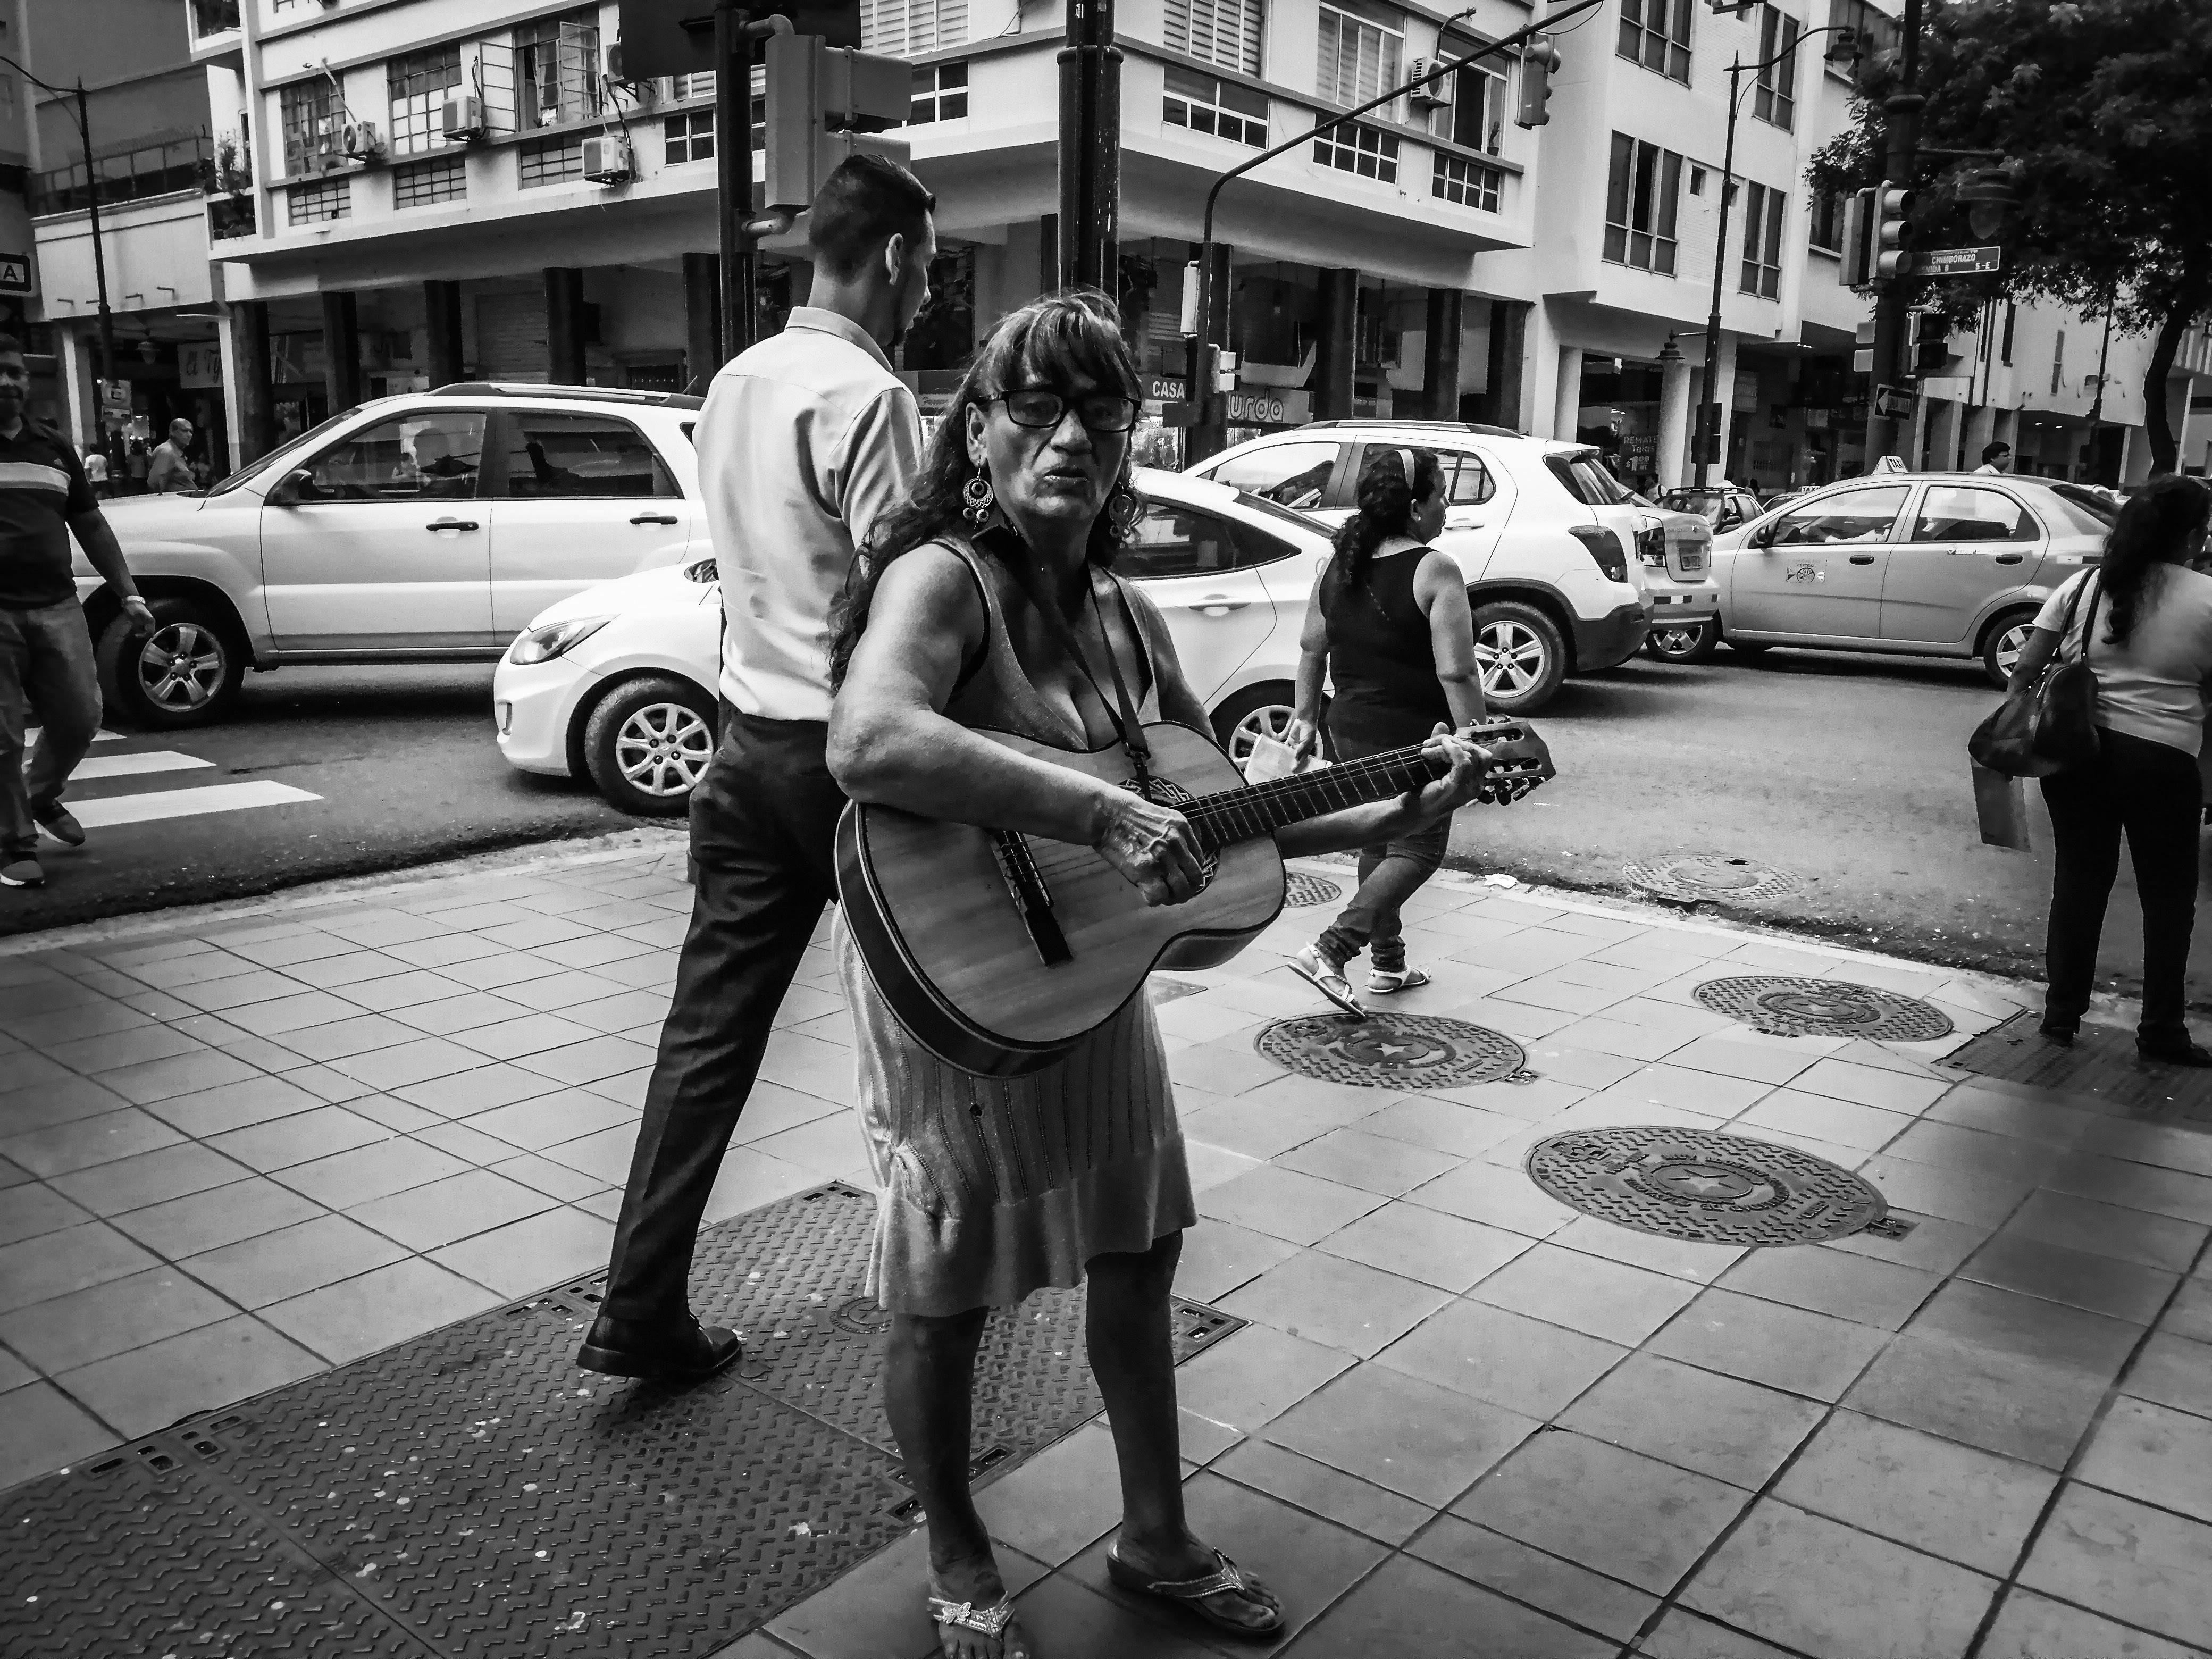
[2044,730,2203,1042]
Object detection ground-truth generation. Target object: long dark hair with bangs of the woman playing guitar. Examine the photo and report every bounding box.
[830,288,1144,690]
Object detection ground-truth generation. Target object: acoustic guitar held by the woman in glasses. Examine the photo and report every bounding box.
[836,719,1555,1077]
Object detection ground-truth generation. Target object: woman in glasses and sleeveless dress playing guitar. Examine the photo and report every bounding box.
[830,294,1480,1659]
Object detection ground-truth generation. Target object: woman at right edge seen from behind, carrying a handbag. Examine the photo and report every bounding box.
[2010,478,2212,1066]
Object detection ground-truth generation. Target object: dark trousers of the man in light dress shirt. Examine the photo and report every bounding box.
[602,703,845,1321]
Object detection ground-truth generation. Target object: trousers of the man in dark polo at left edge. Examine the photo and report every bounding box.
[0,599,99,858]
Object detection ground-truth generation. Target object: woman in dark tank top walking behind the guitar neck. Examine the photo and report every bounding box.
[1289,447,1487,1013]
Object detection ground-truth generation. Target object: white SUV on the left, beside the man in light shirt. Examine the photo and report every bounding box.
[78,385,708,725]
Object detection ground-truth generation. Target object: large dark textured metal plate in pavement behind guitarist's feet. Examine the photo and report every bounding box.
[0,1186,1241,1659]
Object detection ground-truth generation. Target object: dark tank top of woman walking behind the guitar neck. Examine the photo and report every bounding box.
[1321,547,1451,755]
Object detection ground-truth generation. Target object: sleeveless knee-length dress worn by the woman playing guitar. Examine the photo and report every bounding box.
[834,542,1197,1316]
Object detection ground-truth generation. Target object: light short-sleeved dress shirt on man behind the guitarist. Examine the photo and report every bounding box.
[694,305,923,721]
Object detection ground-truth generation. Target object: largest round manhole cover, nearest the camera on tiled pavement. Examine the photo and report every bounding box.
[1529,1126,1889,1245]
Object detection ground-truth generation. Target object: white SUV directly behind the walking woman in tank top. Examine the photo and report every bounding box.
[1190,420,1665,715]
